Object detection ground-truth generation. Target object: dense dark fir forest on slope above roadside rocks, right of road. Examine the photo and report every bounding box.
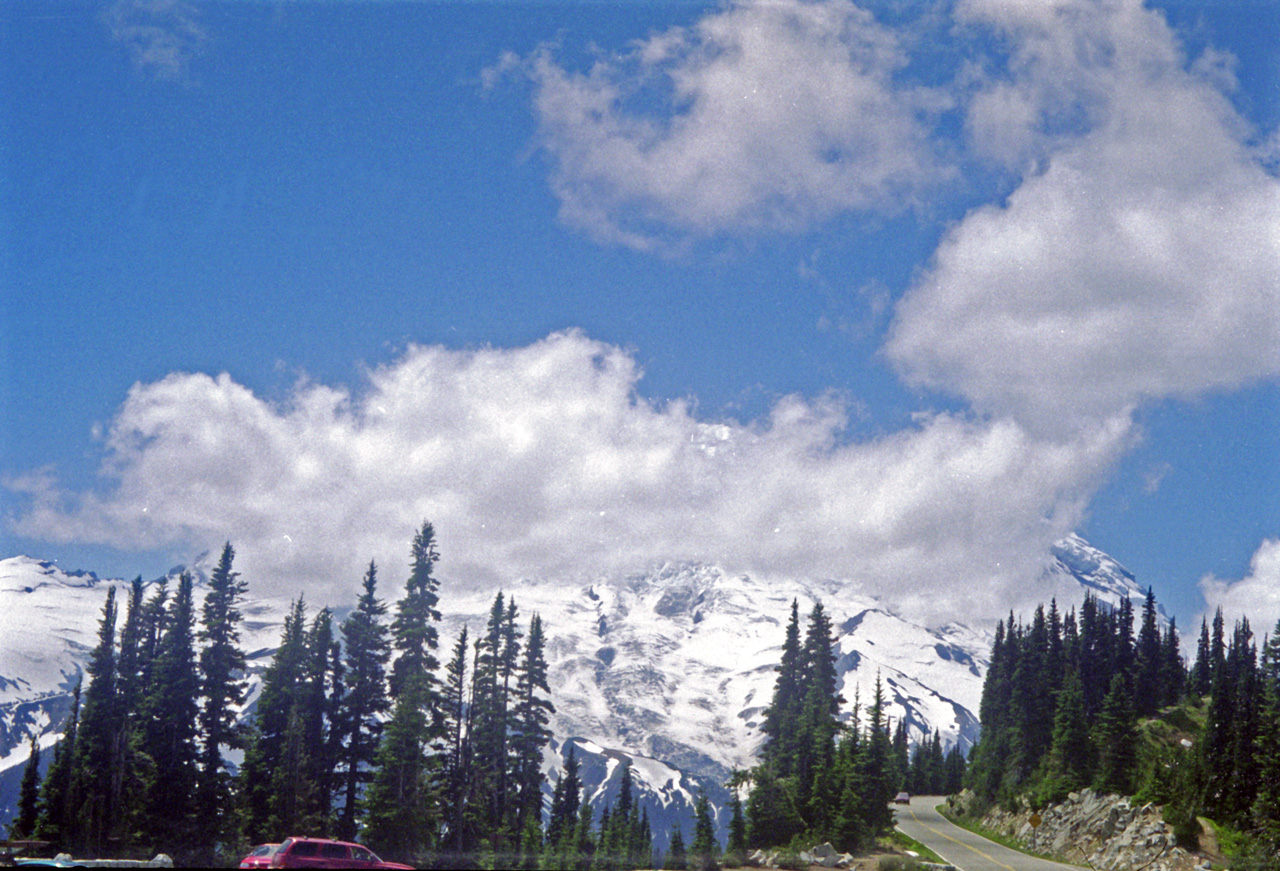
[966,590,1280,871]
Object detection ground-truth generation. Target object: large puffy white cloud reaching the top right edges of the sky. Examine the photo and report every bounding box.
[886,0,1280,428]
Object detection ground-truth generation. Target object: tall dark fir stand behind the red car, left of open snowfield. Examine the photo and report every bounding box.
[10,523,576,867]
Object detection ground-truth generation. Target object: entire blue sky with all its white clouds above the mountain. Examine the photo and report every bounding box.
[0,0,1280,626]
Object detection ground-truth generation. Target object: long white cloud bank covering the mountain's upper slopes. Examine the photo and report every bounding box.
[9,332,1128,620]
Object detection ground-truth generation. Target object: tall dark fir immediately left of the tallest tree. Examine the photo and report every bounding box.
[337,561,390,840]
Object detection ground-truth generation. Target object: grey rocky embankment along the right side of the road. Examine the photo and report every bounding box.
[962,789,1203,871]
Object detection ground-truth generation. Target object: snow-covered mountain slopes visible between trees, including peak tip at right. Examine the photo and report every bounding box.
[0,537,1143,829]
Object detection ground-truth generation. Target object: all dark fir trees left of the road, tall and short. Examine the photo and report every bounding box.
[10,523,964,871]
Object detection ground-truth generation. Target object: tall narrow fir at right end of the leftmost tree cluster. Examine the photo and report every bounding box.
[196,542,248,849]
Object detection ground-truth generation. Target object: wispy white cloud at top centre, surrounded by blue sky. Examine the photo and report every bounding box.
[503,0,943,248]
